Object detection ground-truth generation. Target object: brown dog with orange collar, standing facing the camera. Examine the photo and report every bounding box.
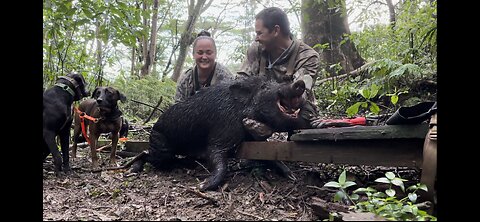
[72,87,127,169]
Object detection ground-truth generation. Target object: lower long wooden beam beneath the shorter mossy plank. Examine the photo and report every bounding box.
[236,139,424,167]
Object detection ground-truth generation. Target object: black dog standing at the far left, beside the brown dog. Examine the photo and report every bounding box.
[43,73,89,176]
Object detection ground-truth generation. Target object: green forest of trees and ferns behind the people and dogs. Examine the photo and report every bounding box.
[43,0,437,122]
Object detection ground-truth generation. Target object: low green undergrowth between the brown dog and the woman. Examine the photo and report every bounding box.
[113,75,176,123]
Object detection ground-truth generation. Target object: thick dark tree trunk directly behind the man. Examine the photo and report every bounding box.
[302,0,365,75]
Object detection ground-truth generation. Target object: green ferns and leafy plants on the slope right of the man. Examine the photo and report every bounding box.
[315,1,437,116]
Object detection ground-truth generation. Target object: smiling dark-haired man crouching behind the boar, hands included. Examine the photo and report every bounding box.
[237,7,320,138]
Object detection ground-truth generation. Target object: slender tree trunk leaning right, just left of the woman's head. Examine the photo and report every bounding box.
[171,0,206,82]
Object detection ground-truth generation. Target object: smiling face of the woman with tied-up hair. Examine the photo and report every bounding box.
[193,39,217,69]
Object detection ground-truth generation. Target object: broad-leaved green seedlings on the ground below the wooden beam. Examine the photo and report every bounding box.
[324,170,437,221]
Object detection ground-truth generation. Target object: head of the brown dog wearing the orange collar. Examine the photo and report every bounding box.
[92,86,127,112]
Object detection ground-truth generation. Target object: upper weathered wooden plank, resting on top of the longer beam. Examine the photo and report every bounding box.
[291,124,428,141]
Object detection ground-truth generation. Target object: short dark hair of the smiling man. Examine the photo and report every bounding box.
[255,7,291,36]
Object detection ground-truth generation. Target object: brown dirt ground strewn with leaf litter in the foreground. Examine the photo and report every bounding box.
[43,142,418,221]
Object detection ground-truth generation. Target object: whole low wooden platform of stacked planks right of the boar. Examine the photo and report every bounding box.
[237,124,428,167]
